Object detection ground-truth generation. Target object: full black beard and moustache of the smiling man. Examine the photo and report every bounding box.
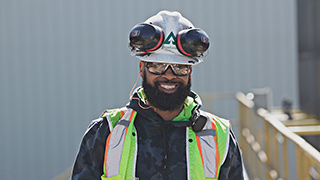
[142,73,191,111]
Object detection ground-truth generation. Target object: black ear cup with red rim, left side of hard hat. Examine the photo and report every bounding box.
[129,23,164,52]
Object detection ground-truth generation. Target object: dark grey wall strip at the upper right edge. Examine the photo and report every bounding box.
[297,0,320,119]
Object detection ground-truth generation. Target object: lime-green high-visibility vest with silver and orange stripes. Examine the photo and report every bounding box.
[101,108,230,180]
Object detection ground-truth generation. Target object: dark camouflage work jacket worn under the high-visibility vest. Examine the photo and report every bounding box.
[72,92,243,180]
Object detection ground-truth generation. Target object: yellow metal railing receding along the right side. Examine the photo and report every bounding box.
[236,93,320,180]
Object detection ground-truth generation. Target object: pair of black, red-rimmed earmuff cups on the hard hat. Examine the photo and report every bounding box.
[129,23,209,58]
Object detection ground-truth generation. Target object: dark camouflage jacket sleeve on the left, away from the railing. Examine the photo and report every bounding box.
[71,118,110,180]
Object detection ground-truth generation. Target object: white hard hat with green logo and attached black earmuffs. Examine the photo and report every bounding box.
[129,11,209,65]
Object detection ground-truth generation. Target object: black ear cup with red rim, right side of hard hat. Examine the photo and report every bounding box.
[176,29,209,57]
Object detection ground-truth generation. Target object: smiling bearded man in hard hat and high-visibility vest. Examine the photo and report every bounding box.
[72,11,243,180]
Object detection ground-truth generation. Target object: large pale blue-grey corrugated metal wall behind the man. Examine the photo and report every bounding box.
[0,0,298,179]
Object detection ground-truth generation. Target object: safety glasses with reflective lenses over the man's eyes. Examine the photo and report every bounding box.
[145,62,190,76]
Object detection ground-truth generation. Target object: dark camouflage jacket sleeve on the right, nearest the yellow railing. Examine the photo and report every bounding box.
[218,130,244,180]
